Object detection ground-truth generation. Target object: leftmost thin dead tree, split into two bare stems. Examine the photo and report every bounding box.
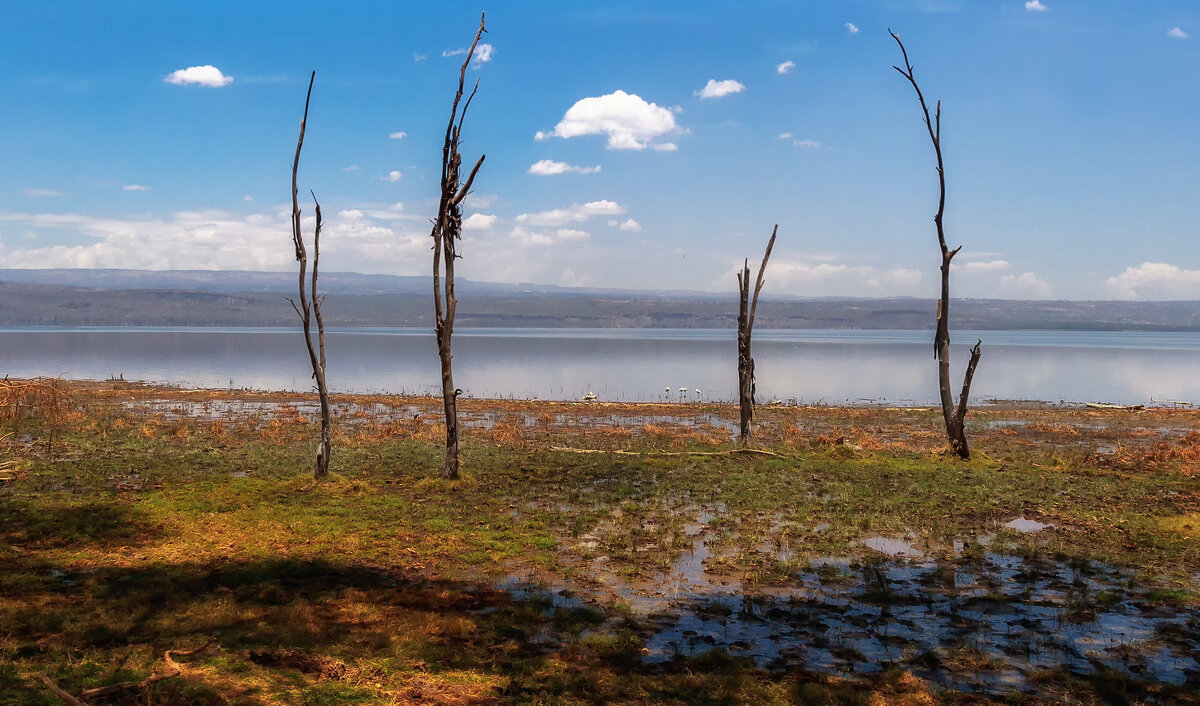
[288,71,332,480]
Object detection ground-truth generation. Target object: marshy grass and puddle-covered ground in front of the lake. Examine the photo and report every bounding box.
[0,381,1200,704]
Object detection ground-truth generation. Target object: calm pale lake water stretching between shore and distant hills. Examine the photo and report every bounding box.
[0,328,1200,403]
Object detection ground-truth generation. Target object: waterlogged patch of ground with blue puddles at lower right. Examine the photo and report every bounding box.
[496,507,1200,698]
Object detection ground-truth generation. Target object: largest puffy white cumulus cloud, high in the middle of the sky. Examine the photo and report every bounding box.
[534,90,680,150]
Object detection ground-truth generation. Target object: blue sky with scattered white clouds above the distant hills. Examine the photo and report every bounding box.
[0,0,1200,299]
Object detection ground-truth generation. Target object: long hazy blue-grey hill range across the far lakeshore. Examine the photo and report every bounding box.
[0,270,1200,331]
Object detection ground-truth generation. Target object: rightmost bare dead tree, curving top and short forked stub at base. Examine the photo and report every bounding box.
[888,30,983,459]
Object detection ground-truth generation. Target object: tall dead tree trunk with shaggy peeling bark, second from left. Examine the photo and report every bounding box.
[432,14,487,478]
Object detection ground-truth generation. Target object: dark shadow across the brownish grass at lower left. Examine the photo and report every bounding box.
[0,558,924,704]
